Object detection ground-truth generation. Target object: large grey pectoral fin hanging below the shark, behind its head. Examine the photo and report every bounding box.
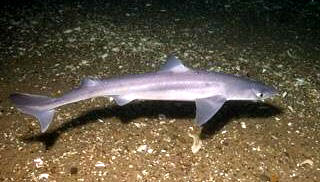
[196,95,226,126]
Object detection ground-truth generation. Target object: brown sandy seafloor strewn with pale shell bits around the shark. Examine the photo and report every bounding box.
[0,0,320,182]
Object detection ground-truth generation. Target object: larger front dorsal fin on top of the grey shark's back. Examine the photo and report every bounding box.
[160,55,190,72]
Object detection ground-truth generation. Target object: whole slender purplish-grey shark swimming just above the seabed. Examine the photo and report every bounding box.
[10,56,276,132]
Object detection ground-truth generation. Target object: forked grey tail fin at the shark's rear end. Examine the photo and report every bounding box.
[9,93,55,133]
